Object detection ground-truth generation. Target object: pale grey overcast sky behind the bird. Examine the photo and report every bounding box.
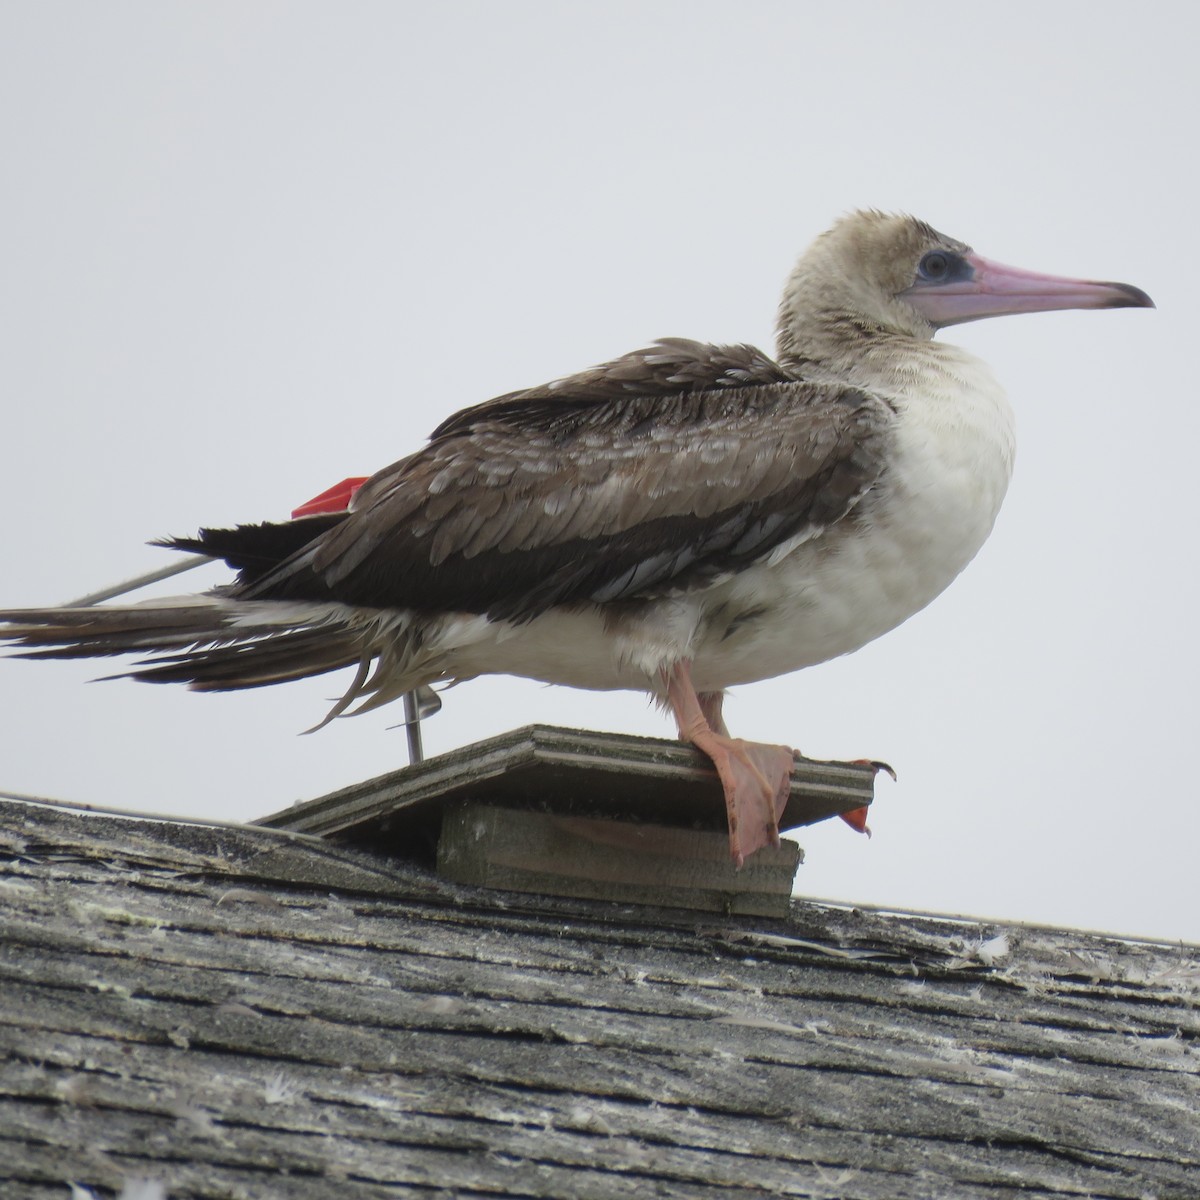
[0,0,1200,941]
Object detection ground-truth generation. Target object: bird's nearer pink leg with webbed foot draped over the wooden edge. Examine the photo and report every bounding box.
[662,660,794,866]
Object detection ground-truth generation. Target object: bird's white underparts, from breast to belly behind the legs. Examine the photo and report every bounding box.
[434,347,1013,691]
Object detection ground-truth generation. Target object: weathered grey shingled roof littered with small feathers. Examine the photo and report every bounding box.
[0,787,1200,1200]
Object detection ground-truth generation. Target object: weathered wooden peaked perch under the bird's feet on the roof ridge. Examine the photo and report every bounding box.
[258,725,875,916]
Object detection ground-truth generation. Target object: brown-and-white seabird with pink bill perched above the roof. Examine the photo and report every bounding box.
[0,210,1153,866]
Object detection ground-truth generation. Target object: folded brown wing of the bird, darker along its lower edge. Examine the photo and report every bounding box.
[240,343,890,619]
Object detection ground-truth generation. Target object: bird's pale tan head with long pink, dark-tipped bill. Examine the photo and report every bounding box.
[779,211,1154,356]
